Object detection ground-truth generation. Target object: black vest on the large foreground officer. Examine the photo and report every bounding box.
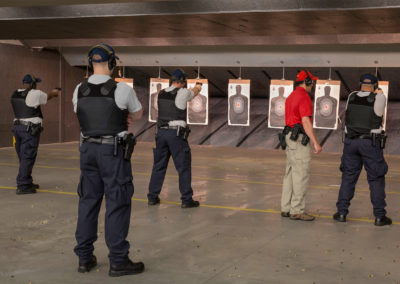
[76,79,128,137]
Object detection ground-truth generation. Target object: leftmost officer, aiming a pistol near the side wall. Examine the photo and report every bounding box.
[11,74,61,194]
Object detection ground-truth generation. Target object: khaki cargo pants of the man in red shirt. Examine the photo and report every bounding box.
[281,133,311,214]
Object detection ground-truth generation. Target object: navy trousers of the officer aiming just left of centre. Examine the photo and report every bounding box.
[147,129,193,203]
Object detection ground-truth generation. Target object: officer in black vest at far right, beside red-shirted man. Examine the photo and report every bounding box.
[333,74,392,226]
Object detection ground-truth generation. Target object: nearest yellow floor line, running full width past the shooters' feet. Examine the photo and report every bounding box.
[0,186,400,225]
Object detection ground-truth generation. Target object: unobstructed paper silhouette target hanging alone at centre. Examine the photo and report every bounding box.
[228,79,250,126]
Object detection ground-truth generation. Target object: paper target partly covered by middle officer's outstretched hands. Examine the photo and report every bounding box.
[187,79,208,125]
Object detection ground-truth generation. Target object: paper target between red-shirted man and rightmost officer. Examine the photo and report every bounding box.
[314,80,340,129]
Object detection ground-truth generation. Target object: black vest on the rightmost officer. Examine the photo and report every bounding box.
[346,92,382,137]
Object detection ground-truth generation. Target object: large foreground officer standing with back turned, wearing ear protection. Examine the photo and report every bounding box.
[73,44,144,276]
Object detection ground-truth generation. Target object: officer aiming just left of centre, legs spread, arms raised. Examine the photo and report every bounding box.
[147,69,201,208]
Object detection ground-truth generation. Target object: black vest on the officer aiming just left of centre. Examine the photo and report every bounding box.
[158,88,187,126]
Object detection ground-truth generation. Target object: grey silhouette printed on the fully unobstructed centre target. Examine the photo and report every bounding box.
[229,85,249,125]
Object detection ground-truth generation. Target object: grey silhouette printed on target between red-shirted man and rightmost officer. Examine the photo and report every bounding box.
[315,86,338,128]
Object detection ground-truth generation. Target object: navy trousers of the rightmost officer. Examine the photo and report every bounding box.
[336,138,388,217]
